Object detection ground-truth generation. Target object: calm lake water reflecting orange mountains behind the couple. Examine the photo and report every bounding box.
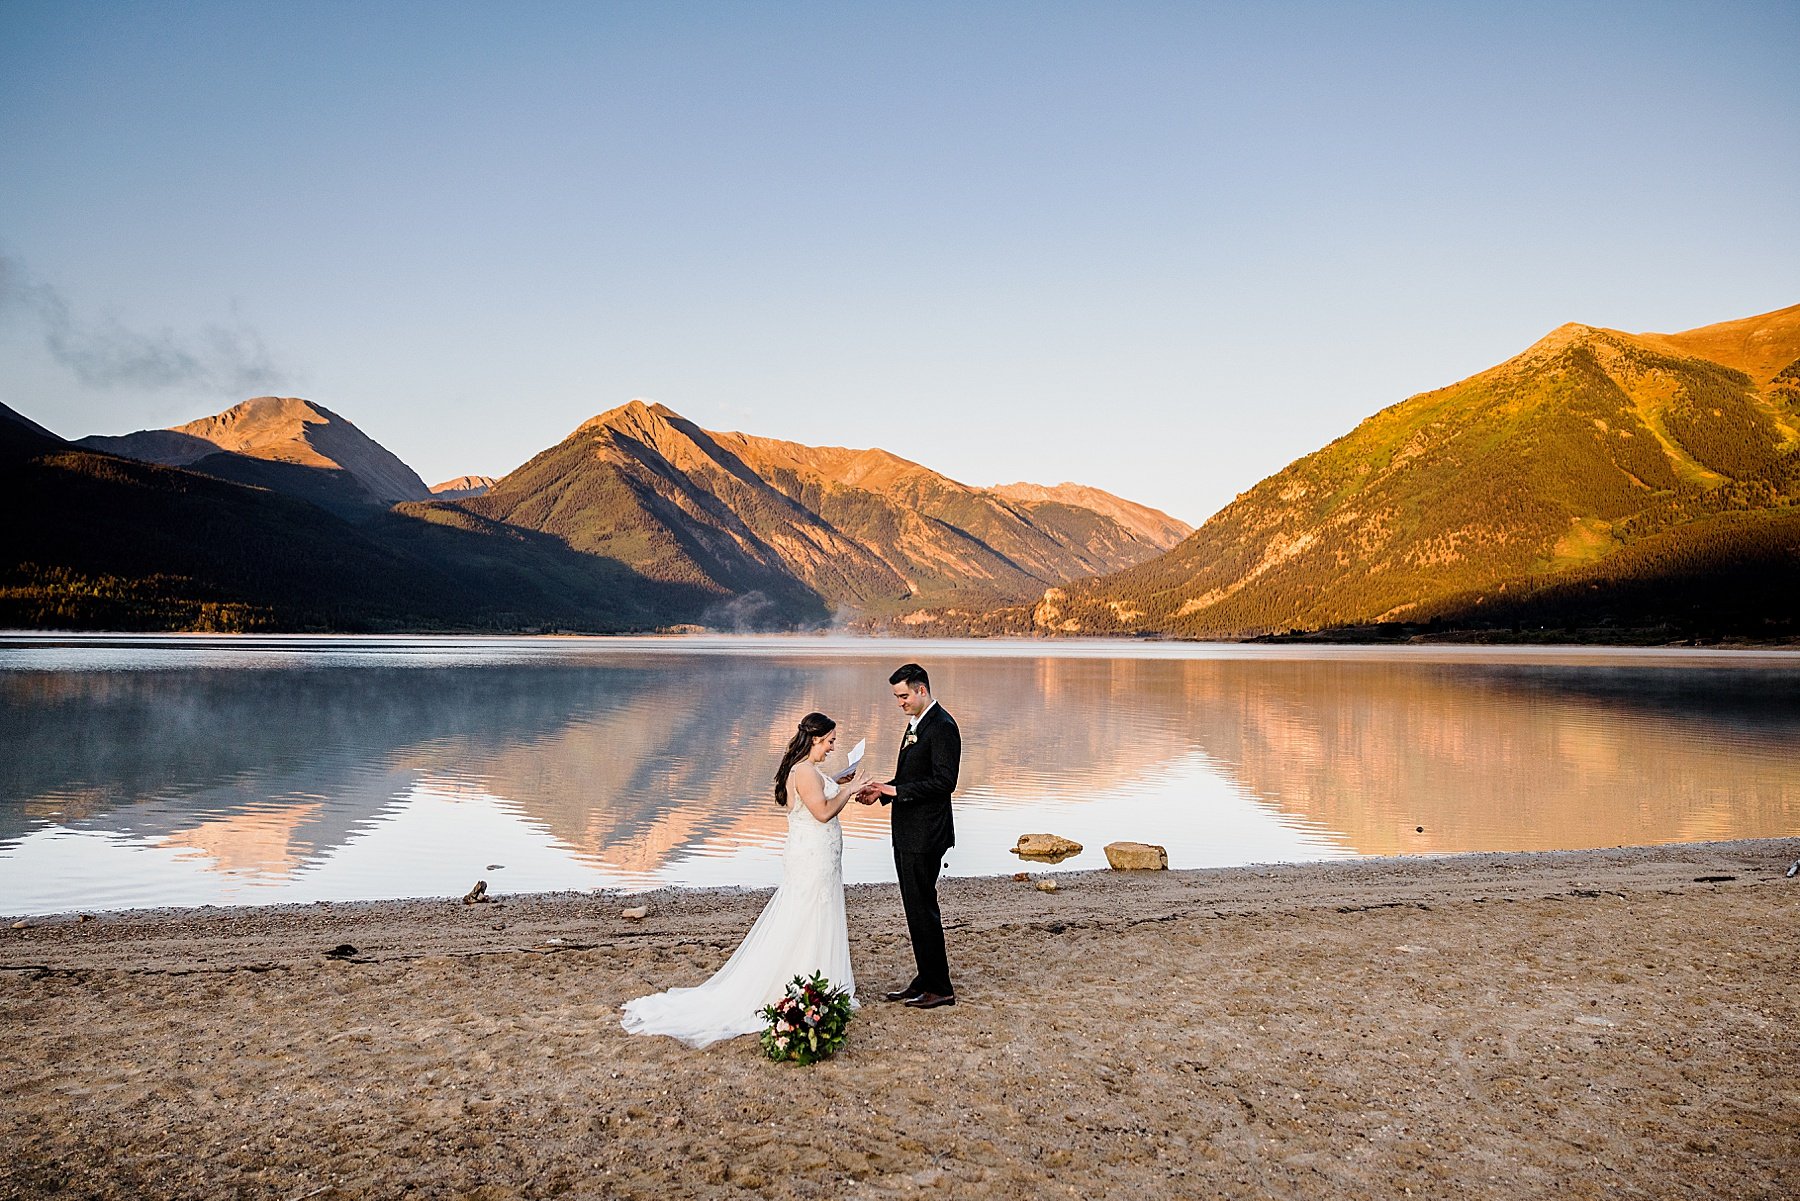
[0,636,1800,913]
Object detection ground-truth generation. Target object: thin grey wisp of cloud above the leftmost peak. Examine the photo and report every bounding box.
[0,256,290,396]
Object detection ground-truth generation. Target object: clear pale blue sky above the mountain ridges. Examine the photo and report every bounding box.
[0,0,1800,522]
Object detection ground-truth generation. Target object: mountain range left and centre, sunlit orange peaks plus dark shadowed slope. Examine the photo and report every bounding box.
[0,398,1174,632]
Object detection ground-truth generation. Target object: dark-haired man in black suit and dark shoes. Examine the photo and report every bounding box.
[857,663,963,1008]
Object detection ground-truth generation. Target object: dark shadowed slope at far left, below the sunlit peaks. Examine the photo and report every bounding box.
[0,411,698,630]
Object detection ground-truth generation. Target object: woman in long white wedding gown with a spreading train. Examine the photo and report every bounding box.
[621,713,857,1048]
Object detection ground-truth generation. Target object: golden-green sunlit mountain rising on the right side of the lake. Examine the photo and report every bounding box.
[952,306,1800,637]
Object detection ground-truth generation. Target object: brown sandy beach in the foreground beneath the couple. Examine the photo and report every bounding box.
[0,839,1800,1199]
